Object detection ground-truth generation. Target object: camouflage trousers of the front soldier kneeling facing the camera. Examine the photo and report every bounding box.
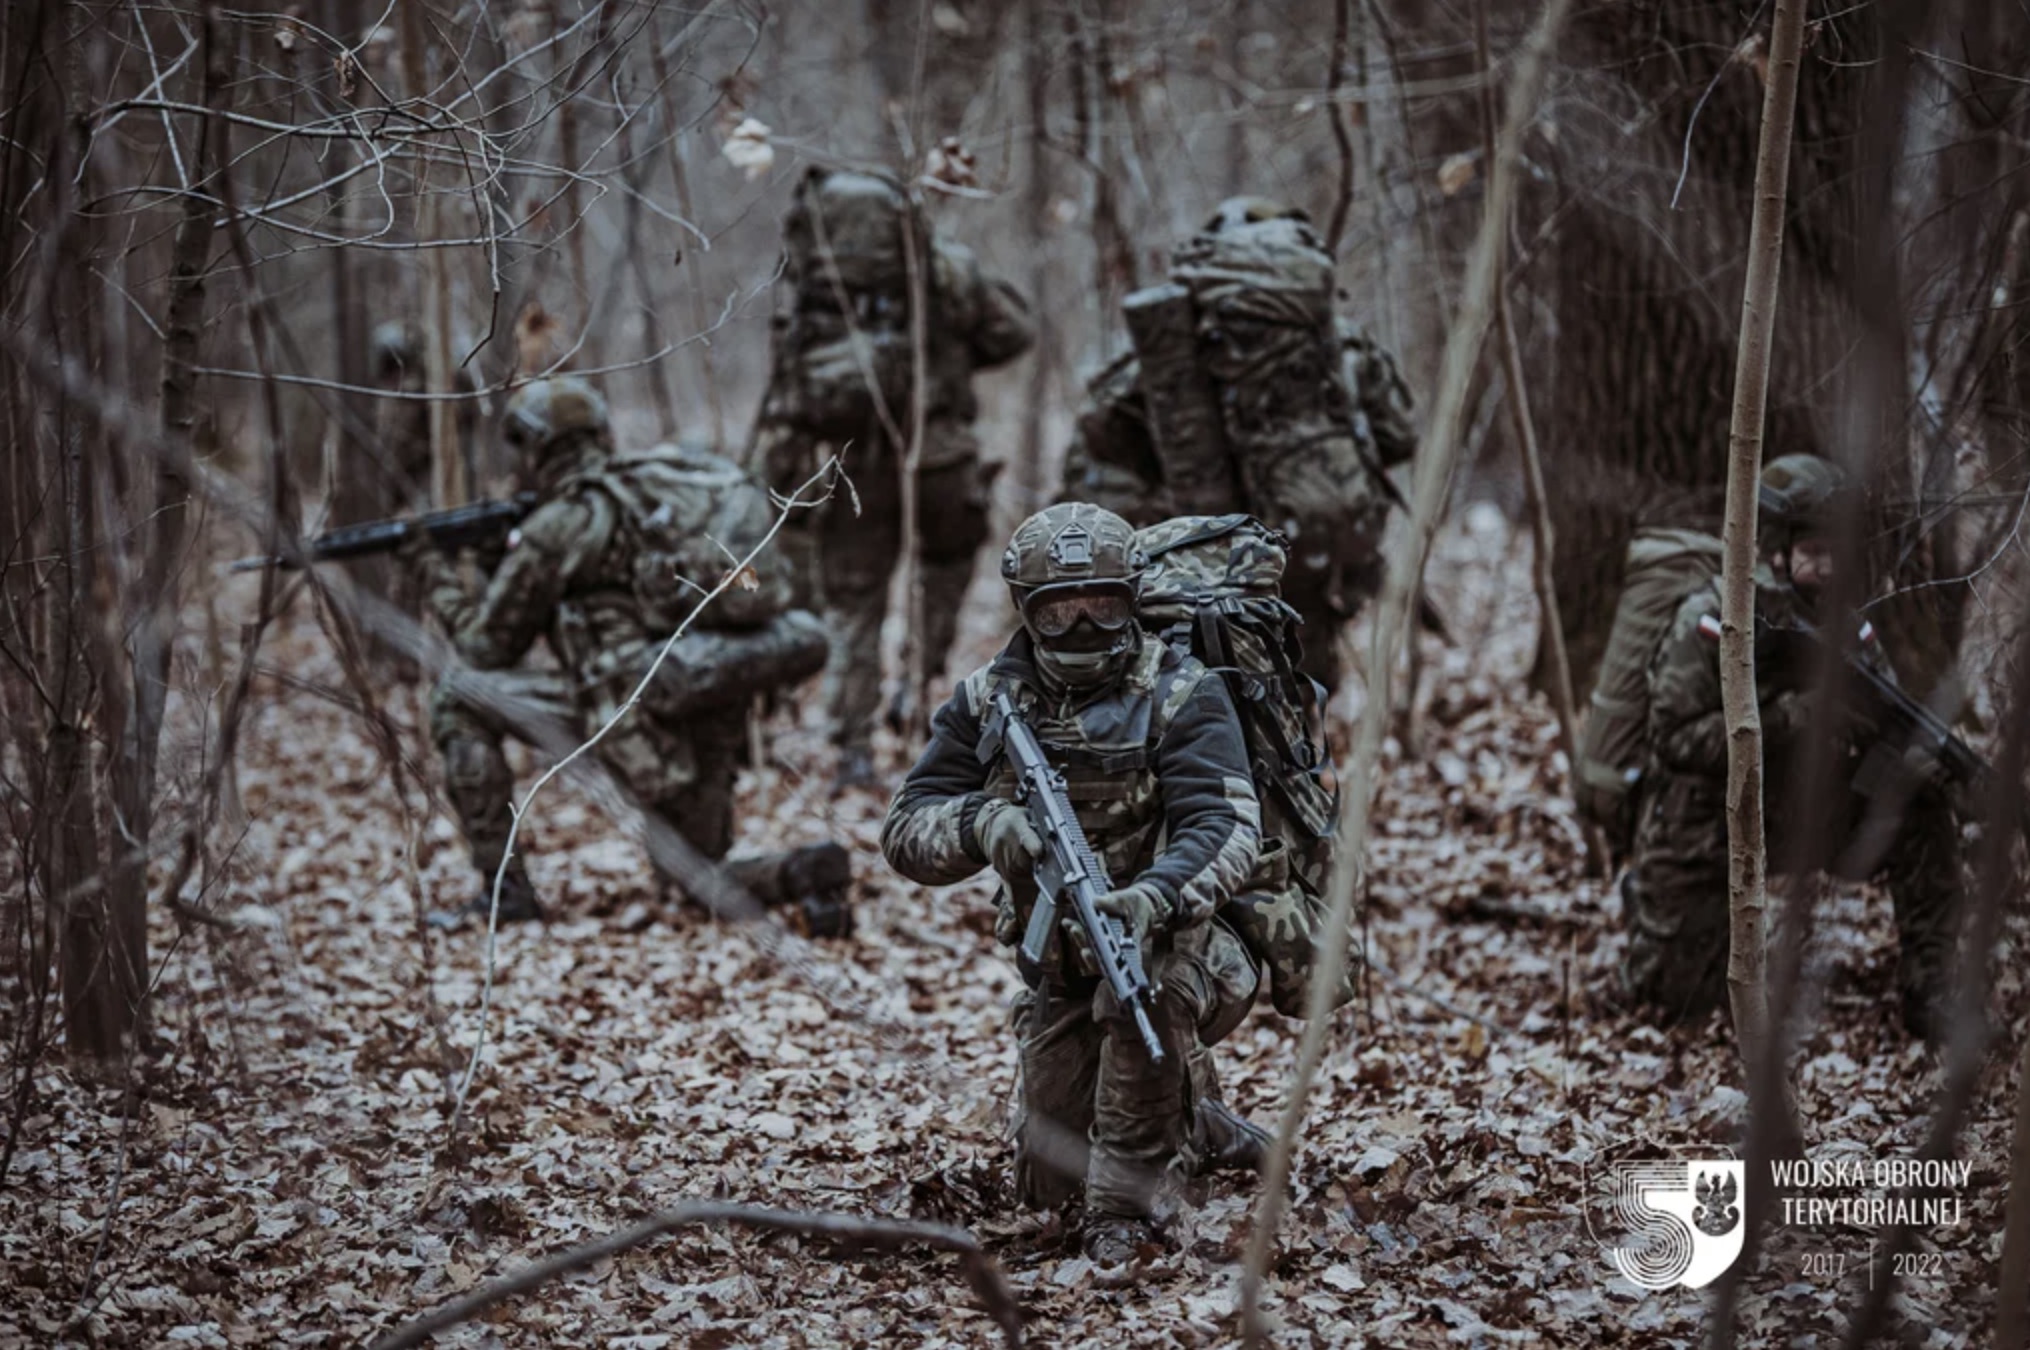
[1015,922,1261,1220]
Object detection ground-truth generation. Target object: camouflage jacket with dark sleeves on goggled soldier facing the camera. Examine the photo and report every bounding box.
[881,633,1261,932]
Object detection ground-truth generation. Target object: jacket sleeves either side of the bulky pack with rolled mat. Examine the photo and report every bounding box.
[1062,319,1417,526]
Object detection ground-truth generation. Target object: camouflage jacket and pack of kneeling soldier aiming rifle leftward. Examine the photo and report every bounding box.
[424,445,788,682]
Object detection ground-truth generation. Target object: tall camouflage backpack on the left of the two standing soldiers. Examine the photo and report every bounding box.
[769,168,932,441]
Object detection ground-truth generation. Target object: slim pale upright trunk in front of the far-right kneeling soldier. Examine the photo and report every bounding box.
[1719,0,1805,1088]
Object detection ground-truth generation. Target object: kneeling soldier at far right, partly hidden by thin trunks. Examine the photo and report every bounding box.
[1622,455,1965,1035]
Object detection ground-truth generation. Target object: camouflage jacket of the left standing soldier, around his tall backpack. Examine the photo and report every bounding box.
[747,240,1035,493]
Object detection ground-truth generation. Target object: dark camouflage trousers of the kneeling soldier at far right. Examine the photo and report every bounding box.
[1620,773,1965,1027]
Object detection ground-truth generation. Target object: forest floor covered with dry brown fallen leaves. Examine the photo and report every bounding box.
[0,508,2026,1350]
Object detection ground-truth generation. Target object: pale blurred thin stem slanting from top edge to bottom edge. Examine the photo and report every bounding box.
[1240,0,1569,1346]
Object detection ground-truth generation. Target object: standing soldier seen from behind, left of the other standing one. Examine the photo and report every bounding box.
[749,168,1033,788]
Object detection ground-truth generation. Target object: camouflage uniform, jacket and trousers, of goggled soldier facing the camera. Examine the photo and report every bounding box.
[881,505,1261,1236]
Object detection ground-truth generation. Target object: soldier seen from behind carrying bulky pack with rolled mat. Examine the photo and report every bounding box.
[1064,197,1417,688]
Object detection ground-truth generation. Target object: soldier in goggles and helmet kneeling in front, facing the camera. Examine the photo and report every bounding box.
[881,503,1265,1265]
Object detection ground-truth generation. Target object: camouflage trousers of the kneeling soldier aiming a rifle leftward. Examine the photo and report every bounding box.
[430,670,767,885]
